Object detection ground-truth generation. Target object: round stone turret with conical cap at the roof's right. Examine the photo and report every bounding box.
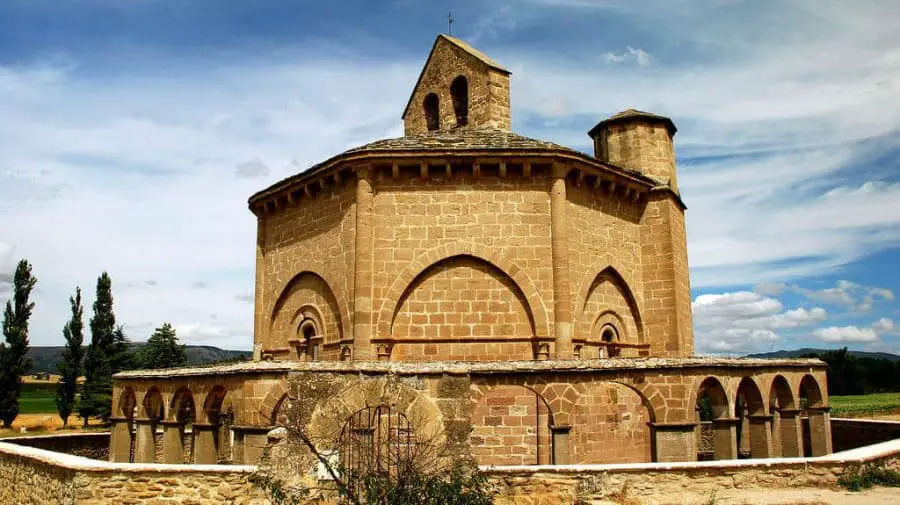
[588,109,678,190]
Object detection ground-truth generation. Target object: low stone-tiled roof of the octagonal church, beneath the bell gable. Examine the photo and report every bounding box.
[250,128,655,202]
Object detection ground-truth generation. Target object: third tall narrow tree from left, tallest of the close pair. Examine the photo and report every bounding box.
[78,272,116,425]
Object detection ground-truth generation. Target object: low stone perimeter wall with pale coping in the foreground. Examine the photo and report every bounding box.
[0,432,900,505]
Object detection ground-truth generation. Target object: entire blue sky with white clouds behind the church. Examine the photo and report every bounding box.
[0,0,900,354]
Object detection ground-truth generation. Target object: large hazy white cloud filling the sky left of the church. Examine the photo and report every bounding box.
[0,53,420,349]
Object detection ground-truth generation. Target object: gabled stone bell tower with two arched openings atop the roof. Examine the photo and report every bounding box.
[403,34,511,135]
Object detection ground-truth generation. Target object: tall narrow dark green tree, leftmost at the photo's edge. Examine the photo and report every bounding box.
[0,259,37,428]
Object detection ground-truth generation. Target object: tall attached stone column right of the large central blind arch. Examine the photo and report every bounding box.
[550,164,572,359]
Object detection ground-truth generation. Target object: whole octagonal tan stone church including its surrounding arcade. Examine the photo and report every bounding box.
[110,35,831,465]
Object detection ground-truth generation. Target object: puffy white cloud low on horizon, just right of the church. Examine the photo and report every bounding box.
[691,291,827,353]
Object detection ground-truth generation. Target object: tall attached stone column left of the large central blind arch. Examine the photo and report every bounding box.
[353,166,375,361]
